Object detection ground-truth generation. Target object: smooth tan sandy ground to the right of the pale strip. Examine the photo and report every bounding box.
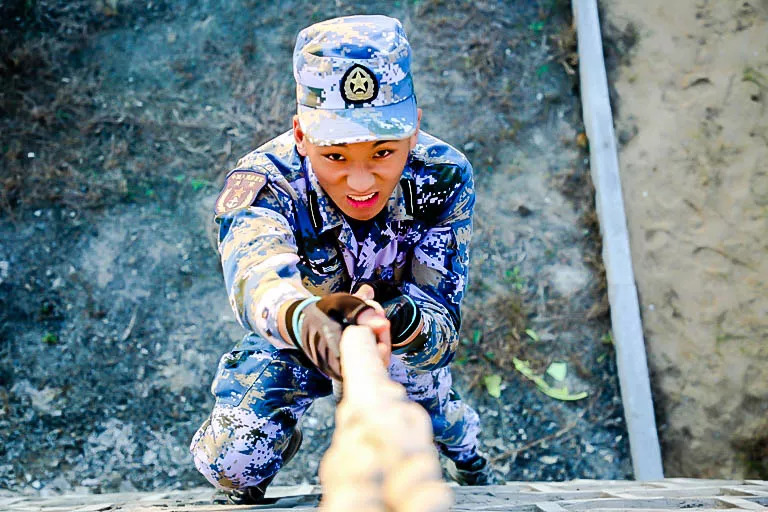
[604,0,768,478]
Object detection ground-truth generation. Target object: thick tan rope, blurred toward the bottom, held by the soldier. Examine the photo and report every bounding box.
[320,326,453,512]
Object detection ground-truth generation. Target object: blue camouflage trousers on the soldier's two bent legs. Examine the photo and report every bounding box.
[190,335,480,489]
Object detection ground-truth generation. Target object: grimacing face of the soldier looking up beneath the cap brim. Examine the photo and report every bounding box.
[293,112,421,220]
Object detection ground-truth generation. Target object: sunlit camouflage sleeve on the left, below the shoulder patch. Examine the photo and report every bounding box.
[216,188,311,348]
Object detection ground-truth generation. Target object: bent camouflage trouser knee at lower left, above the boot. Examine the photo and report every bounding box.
[189,404,295,489]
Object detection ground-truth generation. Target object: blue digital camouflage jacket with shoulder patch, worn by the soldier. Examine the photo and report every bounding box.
[216,131,475,370]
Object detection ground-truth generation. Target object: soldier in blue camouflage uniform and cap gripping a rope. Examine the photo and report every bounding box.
[190,16,491,502]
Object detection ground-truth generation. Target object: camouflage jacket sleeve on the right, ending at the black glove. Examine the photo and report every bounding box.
[401,163,475,370]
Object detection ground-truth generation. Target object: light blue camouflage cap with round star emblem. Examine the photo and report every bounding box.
[293,16,417,145]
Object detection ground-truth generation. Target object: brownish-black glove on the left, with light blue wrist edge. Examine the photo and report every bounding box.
[285,293,372,380]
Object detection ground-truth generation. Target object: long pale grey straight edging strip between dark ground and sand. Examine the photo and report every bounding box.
[572,0,664,480]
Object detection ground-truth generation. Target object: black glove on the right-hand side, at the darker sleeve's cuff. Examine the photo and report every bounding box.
[352,279,426,354]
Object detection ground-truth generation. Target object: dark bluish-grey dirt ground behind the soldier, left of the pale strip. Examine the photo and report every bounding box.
[0,0,631,494]
